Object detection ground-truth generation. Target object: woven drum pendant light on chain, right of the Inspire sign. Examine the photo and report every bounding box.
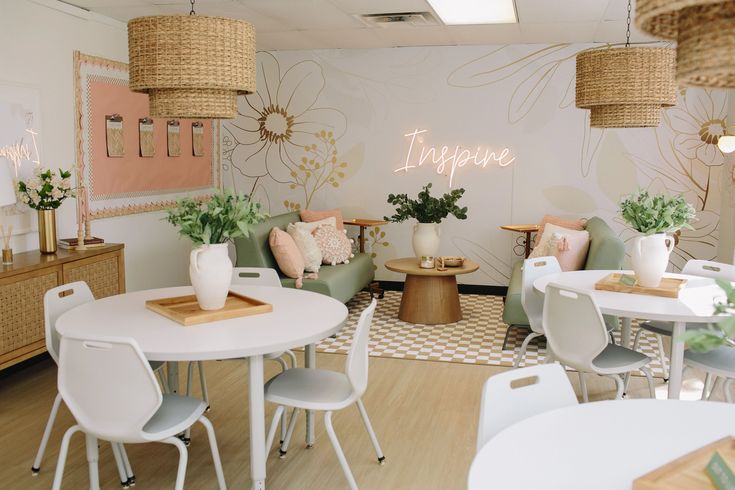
[576,1,676,128]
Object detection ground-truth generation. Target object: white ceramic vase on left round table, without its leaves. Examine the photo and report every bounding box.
[189,243,232,310]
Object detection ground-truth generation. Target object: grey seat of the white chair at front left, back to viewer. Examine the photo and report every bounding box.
[143,393,207,440]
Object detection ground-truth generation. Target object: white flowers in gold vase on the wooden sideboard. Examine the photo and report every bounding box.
[18,167,74,254]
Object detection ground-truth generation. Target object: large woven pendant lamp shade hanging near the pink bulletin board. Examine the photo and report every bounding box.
[128,15,255,119]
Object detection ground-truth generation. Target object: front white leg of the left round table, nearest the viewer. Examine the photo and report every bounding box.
[248,355,266,490]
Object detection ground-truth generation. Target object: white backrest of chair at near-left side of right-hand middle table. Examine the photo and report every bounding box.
[544,282,610,372]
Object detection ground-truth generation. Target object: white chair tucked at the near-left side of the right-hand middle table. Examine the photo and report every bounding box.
[544,283,656,402]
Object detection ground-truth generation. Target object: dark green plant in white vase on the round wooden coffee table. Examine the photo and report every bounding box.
[383,183,467,259]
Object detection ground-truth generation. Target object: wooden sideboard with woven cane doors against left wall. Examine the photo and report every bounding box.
[0,244,125,370]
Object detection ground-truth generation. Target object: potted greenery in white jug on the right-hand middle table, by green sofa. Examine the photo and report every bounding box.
[620,191,695,287]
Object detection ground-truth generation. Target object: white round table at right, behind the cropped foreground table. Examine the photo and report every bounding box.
[533,270,725,398]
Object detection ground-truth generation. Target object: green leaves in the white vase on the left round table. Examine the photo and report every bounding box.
[166,190,266,246]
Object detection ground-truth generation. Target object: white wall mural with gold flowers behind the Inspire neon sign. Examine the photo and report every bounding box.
[222,44,732,285]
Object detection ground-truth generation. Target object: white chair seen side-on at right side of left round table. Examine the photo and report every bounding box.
[265,299,385,489]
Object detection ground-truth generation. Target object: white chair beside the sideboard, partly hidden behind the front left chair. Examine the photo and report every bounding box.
[31,281,165,487]
